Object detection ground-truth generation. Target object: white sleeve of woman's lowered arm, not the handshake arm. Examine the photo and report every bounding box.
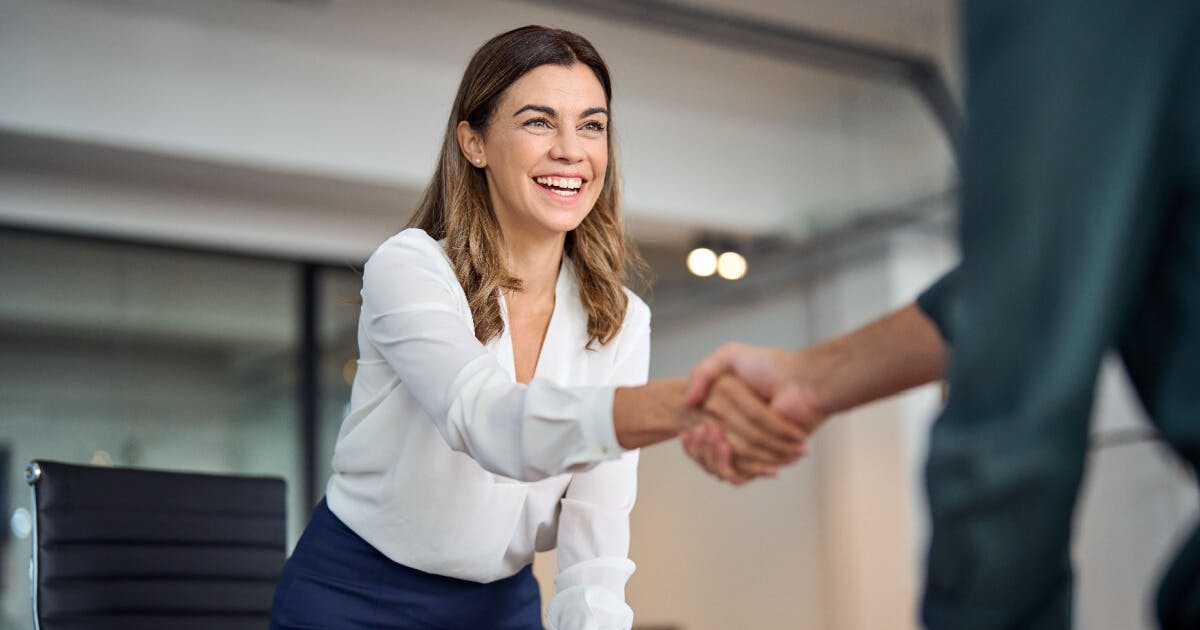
[546,301,650,630]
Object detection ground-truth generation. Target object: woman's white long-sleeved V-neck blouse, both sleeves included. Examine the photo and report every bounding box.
[326,229,650,630]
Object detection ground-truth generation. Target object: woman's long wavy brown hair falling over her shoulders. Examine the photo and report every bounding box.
[409,26,646,346]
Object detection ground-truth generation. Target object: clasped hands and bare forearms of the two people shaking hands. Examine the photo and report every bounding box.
[613,305,948,485]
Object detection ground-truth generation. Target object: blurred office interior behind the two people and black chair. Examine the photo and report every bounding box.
[0,0,1198,630]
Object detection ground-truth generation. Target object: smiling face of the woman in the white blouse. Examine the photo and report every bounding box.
[460,64,608,239]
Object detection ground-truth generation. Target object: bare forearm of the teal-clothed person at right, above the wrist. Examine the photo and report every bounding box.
[791,305,949,415]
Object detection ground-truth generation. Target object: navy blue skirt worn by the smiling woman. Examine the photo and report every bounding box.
[271,500,542,630]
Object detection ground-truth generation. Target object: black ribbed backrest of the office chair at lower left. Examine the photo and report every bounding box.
[25,461,287,630]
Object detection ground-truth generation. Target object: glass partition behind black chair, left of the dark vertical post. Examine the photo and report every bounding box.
[0,230,314,629]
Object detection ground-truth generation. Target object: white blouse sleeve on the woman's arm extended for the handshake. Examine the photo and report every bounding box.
[361,229,623,481]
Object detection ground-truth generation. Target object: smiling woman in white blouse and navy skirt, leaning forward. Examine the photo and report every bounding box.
[271,26,801,630]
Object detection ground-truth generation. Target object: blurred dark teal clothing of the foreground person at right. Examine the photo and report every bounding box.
[918,0,1200,630]
